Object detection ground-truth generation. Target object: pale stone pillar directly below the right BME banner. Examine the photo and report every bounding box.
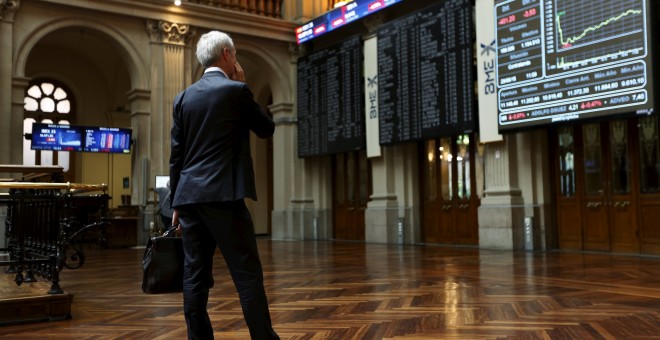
[479,135,525,250]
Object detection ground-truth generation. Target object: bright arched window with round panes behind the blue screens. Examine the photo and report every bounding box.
[23,79,75,172]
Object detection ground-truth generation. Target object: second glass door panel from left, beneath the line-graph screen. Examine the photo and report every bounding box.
[582,123,603,195]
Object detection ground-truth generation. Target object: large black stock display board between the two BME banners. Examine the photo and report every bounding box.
[378,0,475,144]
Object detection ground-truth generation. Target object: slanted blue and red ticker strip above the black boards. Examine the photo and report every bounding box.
[296,0,403,44]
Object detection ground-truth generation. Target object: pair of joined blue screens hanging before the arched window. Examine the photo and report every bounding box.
[31,123,132,153]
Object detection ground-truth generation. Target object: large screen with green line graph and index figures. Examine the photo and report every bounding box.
[495,0,653,131]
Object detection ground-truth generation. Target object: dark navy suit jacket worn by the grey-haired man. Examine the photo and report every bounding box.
[170,71,275,207]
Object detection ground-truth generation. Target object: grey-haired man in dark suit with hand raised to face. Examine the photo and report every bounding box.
[170,31,279,339]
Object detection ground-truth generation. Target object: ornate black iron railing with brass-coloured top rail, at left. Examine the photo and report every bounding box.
[0,182,110,294]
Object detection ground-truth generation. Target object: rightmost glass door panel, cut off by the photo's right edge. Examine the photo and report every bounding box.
[638,116,660,193]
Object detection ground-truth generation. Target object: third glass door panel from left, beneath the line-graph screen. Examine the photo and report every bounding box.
[610,120,630,194]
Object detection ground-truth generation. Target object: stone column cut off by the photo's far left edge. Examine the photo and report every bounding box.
[0,0,23,164]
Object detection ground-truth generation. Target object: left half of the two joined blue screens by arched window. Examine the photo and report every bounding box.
[31,123,82,151]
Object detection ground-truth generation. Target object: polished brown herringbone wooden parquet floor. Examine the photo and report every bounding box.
[0,239,660,339]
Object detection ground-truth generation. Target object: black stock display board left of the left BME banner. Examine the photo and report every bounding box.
[298,36,365,157]
